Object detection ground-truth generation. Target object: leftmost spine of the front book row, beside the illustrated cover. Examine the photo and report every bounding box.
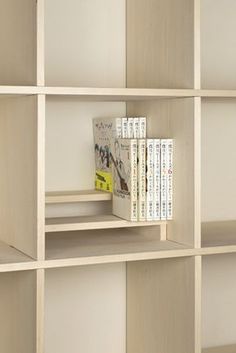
[130,139,138,221]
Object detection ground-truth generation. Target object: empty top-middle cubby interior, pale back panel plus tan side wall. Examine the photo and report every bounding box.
[45,0,194,88]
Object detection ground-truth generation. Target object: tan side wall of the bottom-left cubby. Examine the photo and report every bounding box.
[0,272,36,353]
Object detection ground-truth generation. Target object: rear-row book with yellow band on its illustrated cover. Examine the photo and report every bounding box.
[93,118,122,192]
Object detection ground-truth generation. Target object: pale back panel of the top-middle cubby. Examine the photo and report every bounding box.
[45,0,125,87]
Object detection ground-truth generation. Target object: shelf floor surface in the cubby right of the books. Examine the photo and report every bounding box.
[202,221,236,248]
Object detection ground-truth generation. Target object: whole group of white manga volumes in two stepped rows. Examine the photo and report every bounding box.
[93,117,173,221]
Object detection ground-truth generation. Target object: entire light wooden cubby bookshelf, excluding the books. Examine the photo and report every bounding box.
[0,0,236,353]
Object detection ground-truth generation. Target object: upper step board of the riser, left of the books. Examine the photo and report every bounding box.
[45,190,112,204]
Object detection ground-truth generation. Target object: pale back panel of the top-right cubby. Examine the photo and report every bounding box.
[201,0,236,89]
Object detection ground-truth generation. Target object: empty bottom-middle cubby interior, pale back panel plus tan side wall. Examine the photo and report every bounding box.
[45,258,195,353]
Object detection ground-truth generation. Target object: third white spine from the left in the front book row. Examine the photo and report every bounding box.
[146,139,154,221]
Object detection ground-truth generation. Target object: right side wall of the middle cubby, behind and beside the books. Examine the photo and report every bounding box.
[127,98,195,246]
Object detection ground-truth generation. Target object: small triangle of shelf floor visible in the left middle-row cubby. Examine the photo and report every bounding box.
[0,242,33,265]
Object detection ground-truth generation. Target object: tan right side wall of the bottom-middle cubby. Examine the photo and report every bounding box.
[127,258,194,353]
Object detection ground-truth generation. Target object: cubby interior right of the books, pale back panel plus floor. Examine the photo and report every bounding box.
[201,98,236,246]
